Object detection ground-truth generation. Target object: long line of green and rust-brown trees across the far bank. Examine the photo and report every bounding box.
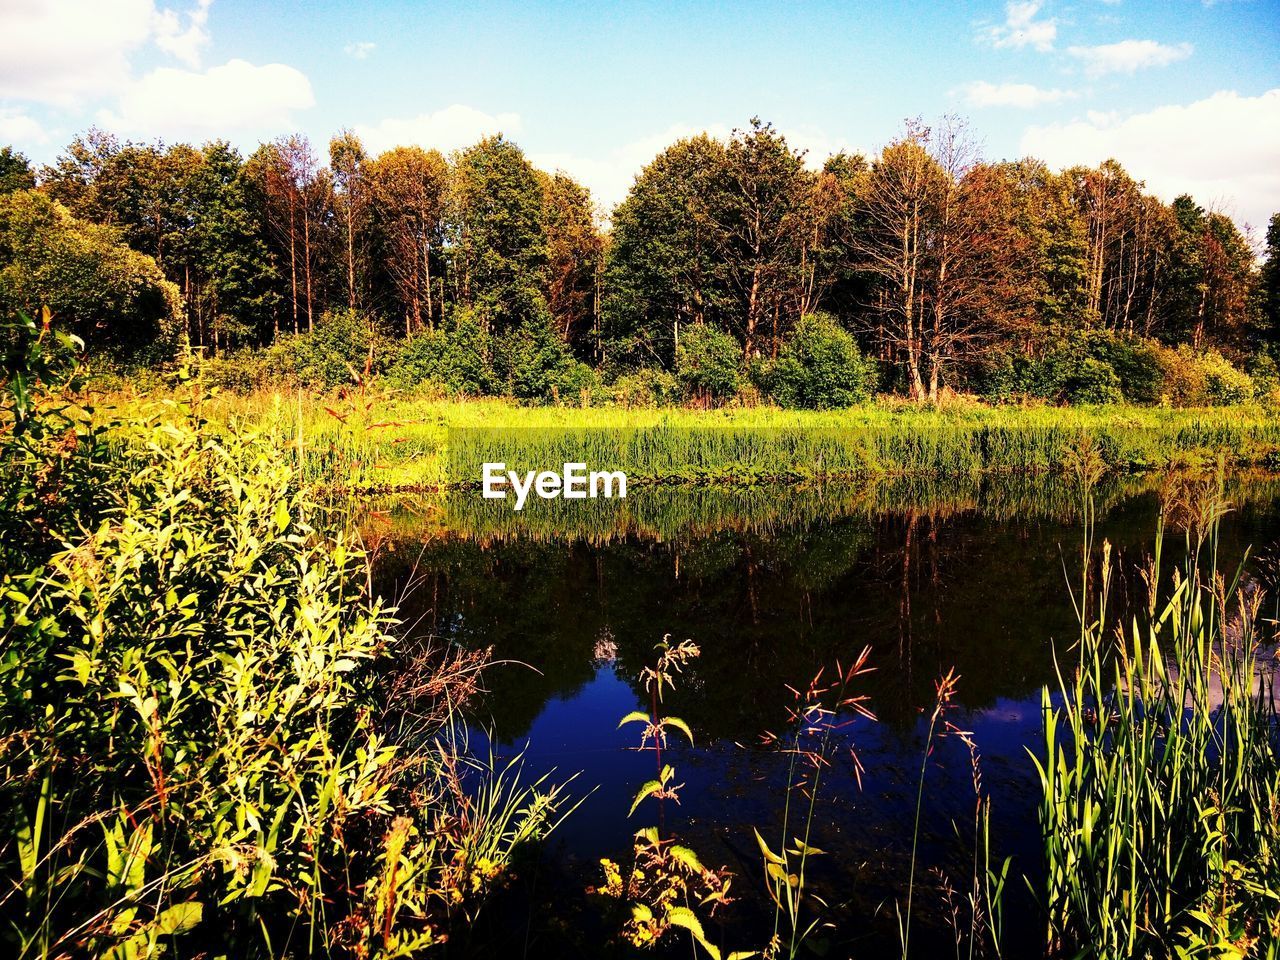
[0,118,1280,398]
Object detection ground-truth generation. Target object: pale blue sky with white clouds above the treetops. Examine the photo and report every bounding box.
[0,0,1280,232]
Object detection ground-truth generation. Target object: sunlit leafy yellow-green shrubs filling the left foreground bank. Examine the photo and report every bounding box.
[0,330,561,957]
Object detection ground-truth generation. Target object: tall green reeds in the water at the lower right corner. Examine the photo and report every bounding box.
[1034,465,1280,957]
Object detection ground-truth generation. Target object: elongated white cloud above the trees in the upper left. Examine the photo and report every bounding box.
[99,60,315,137]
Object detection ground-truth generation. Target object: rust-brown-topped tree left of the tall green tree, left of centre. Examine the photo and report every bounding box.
[365,147,449,335]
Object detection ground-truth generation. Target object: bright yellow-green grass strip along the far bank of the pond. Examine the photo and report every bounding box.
[90,392,1280,493]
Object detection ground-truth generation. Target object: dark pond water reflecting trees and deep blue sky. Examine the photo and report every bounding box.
[370,477,1280,956]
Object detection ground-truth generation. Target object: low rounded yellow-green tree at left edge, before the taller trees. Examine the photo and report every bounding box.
[0,191,183,351]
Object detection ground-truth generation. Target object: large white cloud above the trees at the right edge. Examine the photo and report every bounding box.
[1021,87,1280,234]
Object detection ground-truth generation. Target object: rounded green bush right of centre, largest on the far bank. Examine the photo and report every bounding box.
[760,314,876,410]
